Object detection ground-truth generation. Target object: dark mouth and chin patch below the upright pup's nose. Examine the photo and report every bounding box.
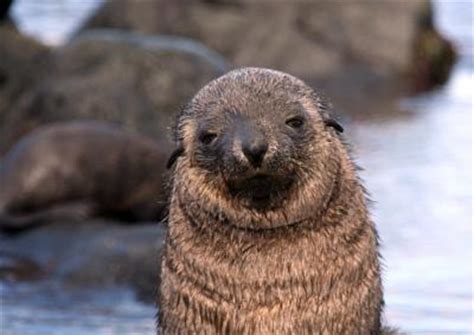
[227,174,293,210]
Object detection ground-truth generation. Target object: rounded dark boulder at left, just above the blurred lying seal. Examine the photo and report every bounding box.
[0,30,227,152]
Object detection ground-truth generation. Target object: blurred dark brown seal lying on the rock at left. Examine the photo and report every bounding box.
[0,121,171,231]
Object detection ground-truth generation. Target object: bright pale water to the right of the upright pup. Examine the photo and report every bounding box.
[350,2,474,334]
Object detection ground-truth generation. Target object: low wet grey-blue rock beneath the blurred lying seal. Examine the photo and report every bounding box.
[0,221,166,302]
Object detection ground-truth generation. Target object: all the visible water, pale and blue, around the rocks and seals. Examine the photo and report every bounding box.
[0,0,474,335]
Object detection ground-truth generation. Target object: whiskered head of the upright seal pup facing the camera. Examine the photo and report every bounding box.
[168,68,342,229]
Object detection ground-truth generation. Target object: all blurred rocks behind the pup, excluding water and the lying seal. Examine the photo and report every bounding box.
[0,0,455,301]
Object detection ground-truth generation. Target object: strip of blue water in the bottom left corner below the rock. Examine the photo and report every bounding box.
[0,282,156,335]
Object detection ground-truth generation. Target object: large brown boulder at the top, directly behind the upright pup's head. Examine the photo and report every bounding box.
[85,0,458,111]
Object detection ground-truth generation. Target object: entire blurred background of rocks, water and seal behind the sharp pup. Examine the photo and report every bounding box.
[0,0,474,335]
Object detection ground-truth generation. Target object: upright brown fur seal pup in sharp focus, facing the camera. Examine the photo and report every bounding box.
[158,68,392,335]
